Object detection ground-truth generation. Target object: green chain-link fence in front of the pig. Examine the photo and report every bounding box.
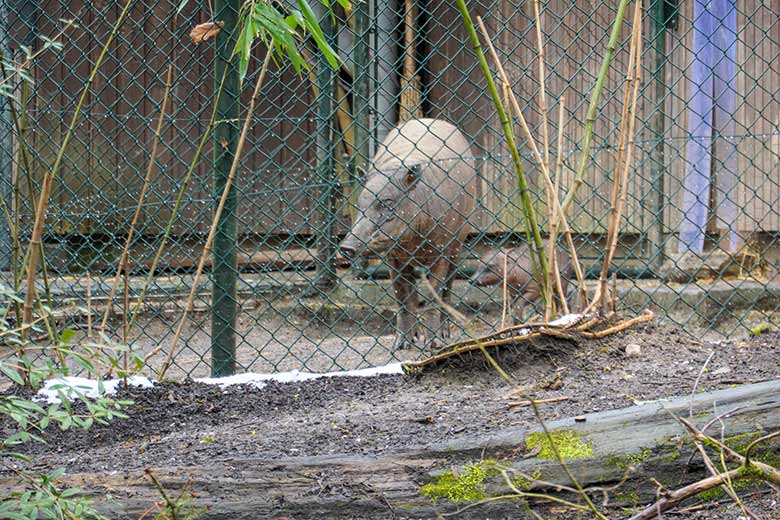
[0,0,780,376]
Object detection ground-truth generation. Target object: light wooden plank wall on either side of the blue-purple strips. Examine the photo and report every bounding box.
[664,0,780,240]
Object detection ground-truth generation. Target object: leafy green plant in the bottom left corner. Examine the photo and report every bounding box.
[0,288,132,520]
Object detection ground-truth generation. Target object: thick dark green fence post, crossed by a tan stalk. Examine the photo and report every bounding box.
[211,0,241,377]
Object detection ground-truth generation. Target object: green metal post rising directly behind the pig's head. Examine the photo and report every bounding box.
[350,0,371,273]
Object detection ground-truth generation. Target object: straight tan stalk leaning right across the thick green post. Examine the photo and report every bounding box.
[155,42,274,380]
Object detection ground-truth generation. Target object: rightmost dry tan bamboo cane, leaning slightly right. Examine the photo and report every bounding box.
[588,2,642,314]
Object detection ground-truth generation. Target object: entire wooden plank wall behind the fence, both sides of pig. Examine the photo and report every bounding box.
[15,0,780,244]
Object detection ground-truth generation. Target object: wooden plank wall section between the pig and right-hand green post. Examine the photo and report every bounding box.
[430,0,649,232]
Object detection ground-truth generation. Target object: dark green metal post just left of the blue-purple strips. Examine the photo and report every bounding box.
[648,0,667,274]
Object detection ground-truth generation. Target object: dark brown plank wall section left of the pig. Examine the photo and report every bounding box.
[19,0,318,237]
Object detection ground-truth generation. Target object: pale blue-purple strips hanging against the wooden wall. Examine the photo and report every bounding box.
[679,0,739,253]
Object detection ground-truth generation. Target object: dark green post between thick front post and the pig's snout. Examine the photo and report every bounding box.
[315,9,339,289]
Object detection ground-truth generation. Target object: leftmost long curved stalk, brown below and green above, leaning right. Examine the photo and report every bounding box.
[22,0,134,338]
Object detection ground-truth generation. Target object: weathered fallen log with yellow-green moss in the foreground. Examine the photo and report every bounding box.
[0,380,780,519]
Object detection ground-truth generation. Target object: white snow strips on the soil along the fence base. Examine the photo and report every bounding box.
[36,363,404,404]
